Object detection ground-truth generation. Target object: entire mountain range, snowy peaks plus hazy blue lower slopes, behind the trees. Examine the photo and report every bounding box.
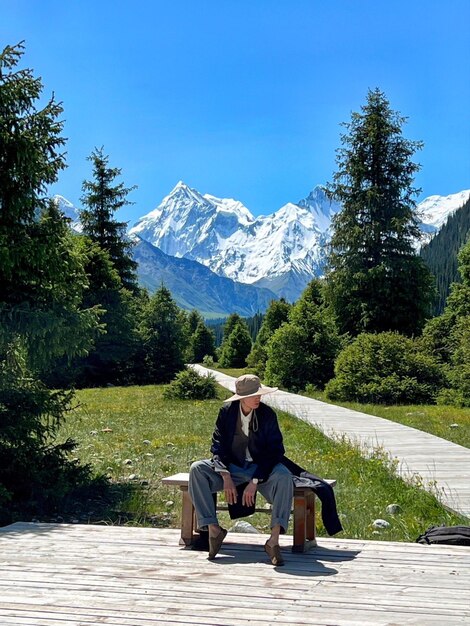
[55,181,470,316]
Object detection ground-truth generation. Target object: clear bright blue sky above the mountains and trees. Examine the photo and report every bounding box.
[0,0,470,224]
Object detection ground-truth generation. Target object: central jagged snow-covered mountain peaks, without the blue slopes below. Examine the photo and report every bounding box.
[129,181,340,299]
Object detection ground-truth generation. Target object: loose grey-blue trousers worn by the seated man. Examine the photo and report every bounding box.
[188,460,294,532]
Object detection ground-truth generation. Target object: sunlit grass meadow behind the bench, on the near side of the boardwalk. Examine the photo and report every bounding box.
[60,386,468,541]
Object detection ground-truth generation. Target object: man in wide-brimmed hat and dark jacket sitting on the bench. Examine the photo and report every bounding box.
[189,374,294,566]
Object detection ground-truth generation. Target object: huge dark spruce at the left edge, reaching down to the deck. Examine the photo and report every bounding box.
[0,44,98,524]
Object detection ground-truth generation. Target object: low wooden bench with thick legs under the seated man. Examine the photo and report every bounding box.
[162,472,336,552]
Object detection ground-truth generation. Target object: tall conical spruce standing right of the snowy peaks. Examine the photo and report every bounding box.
[327,89,433,335]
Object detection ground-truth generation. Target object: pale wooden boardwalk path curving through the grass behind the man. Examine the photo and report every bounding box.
[194,365,470,517]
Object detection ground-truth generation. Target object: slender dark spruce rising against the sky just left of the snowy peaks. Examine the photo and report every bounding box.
[80,148,138,293]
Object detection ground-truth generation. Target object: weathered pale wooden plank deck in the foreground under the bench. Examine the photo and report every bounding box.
[0,523,470,626]
